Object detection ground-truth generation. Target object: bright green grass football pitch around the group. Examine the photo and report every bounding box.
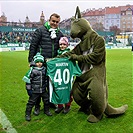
[0,49,133,133]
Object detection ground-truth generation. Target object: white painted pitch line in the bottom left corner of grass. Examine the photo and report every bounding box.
[0,109,17,133]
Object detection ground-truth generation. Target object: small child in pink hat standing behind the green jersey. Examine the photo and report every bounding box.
[55,37,73,114]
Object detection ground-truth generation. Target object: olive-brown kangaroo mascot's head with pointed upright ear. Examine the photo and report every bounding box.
[70,6,92,39]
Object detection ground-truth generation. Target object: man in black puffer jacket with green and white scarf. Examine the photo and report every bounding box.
[28,13,63,115]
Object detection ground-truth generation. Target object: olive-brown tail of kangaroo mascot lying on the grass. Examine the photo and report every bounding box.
[104,104,128,117]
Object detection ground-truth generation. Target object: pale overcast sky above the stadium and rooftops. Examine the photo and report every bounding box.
[0,0,133,22]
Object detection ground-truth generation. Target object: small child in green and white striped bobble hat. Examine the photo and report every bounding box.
[25,53,52,121]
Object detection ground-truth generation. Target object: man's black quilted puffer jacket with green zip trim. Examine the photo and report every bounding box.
[28,26,63,62]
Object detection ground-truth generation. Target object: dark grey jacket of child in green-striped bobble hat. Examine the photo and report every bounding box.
[30,67,47,93]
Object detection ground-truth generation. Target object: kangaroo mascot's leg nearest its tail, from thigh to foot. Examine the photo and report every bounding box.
[87,77,107,123]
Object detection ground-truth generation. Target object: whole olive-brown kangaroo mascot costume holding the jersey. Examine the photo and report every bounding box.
[62,7,128,122]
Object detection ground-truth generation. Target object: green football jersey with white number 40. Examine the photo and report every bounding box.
[47,58,81,104]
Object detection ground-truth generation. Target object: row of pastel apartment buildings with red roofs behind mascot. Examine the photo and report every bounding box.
[82,5,133,32]
